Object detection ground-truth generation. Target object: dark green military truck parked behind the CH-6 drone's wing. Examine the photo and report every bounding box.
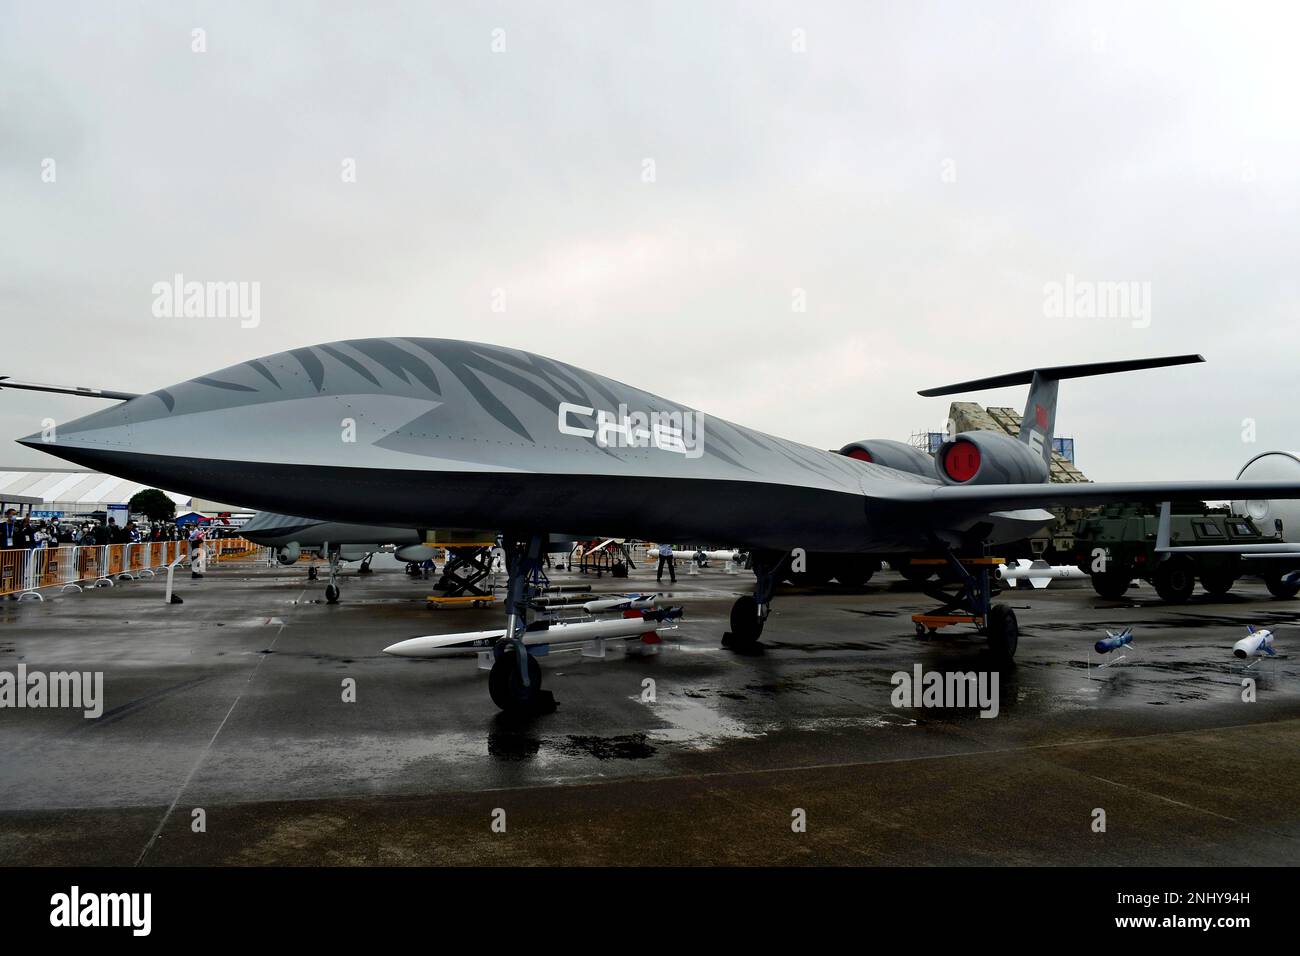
[1074,501,1300,604]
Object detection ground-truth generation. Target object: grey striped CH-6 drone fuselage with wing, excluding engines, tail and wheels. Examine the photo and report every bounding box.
[15,338,1300,553]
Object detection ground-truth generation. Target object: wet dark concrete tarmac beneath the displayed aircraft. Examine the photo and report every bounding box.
[0,562,1300,865]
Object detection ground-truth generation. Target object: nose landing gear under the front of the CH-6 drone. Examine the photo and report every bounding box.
[488,533,555,715]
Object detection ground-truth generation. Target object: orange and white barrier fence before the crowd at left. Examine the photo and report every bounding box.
[0,537,263,597]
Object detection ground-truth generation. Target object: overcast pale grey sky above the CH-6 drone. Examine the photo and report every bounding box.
[0,0,1300,480]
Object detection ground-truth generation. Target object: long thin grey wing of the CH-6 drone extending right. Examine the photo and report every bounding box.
[867,481,1300,514]
